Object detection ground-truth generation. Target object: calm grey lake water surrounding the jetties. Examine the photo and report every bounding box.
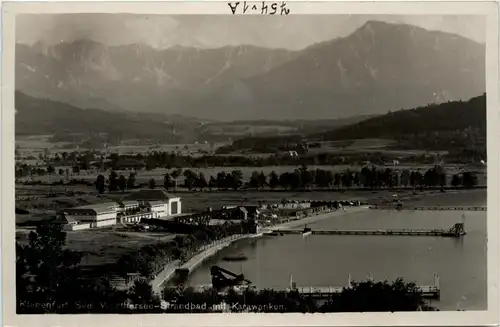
[188,192,487,310]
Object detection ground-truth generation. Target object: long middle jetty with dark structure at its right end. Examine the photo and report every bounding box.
[274,223,466,237]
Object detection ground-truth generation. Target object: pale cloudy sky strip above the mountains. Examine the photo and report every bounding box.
[16,14,486,50]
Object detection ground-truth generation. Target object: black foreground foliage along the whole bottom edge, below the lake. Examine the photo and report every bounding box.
[16,222,436,314]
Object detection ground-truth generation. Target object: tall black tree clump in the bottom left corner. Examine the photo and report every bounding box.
[16,221,131,314]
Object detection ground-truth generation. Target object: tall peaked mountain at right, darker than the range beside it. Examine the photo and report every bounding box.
[188,22,485,119]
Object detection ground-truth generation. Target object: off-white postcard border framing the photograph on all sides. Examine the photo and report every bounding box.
[1,0,500,327]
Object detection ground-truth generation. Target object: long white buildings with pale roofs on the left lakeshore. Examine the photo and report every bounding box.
[59,190,181,230]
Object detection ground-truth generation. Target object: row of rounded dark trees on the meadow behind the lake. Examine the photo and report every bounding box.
[91,166,478,193]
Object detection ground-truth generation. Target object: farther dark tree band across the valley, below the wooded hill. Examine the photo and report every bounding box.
[15,144,486,183]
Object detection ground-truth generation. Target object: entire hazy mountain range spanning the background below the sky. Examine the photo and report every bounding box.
[16,21,486,121]
